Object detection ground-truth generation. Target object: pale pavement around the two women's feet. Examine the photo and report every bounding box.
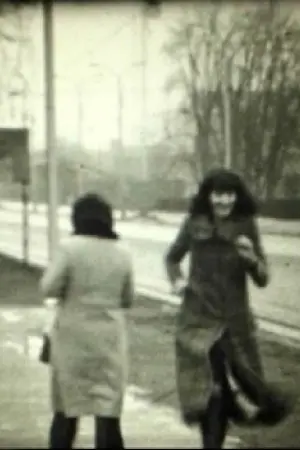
[0,308,239,449]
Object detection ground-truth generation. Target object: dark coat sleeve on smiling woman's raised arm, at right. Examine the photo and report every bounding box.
[249,219,270,287]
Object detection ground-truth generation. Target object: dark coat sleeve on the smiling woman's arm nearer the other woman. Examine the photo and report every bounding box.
[165,218,190,284]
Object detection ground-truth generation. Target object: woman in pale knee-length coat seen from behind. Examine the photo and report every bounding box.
[41,194,133,449]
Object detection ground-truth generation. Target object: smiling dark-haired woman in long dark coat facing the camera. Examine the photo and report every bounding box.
[166,169,291,448]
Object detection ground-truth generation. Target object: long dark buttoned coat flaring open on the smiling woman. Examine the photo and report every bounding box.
[166,216,290,422]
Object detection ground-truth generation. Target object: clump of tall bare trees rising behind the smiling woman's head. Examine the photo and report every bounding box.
[165,5,300,197]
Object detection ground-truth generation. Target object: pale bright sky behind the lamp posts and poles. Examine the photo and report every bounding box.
[2,2,188,153]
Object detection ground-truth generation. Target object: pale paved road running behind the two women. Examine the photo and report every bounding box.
[0,211,300,327]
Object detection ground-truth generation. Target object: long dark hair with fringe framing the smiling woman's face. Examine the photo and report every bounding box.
[189,169,258,217]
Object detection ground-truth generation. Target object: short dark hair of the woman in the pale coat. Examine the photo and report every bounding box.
[71,193,118,239]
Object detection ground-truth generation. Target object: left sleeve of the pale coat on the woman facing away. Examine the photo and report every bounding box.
[40,247,69,299]
